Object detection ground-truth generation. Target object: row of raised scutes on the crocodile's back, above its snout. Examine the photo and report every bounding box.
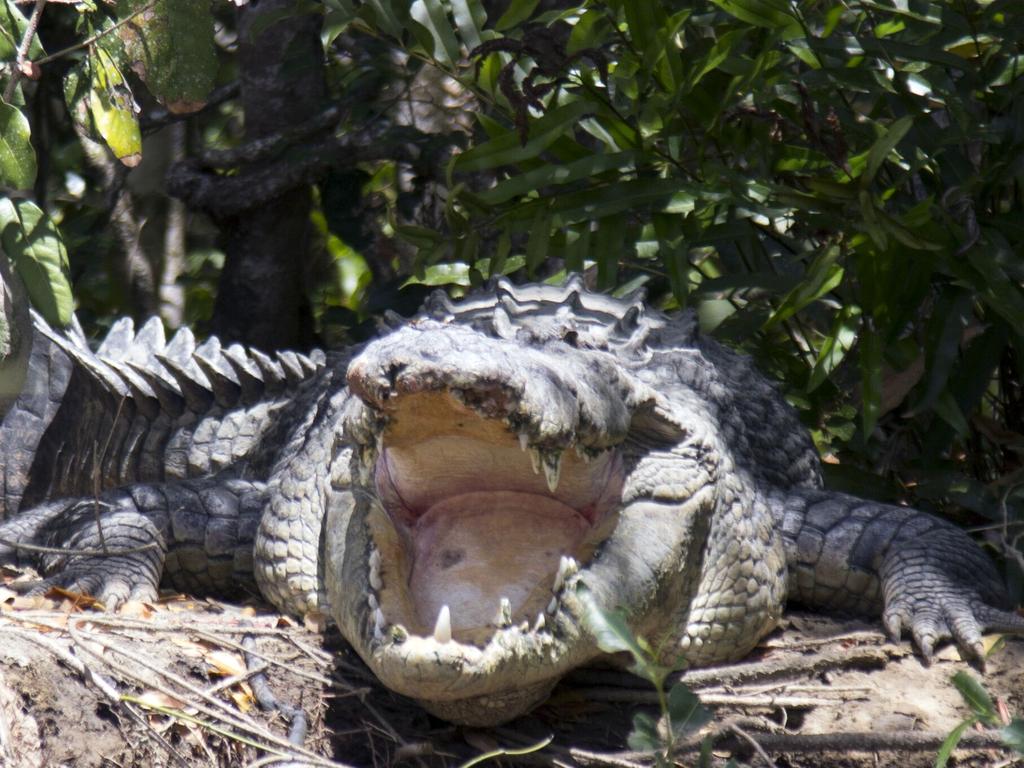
[414,274,695,356]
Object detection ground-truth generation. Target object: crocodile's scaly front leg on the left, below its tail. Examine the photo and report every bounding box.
[0,477,265,608]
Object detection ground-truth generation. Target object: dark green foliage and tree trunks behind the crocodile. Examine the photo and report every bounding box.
[0,0,1024,599]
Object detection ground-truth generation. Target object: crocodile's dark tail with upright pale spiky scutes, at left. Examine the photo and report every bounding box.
[0,315,325,516]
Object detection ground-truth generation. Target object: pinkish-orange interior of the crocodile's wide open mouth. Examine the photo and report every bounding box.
[370,391,622,645]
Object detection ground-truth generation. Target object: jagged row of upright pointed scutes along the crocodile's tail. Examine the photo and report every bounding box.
[36,317,326,417]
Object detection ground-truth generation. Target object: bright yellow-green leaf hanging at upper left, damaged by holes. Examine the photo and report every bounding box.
[89,46,142,168]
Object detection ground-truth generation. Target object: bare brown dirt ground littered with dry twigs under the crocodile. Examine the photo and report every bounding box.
[0,594,1024,768]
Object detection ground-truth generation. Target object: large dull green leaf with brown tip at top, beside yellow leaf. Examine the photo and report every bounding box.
[117,0,216,114]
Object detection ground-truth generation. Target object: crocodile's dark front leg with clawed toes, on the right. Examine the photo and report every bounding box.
[769,489,1024,659]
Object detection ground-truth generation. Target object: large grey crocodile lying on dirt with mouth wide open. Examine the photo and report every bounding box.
[0,276,1024,725]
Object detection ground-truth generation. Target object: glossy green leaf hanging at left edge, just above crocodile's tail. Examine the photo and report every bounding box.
[0,198,74,327]
